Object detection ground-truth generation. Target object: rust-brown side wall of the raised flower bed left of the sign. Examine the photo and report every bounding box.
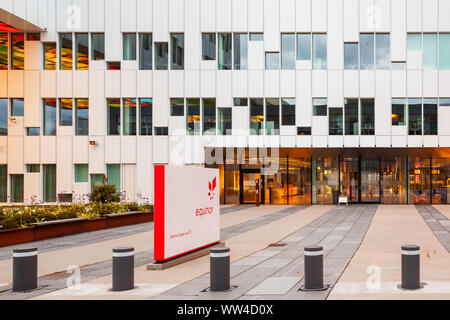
[0,212,153,247]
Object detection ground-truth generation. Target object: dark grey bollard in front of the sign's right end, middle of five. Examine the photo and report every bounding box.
[210,248,230,291]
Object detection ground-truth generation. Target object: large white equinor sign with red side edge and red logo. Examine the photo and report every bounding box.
[154,165,220,262]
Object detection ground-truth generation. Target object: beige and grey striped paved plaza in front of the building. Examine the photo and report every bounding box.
[0,204,450,300]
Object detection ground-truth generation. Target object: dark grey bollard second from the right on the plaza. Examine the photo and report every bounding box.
[303,246,326,291]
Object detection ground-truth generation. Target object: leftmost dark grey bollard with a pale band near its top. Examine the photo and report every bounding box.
[13,248,37,292]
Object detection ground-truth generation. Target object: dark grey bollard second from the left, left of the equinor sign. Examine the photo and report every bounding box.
[112,247,134,291]
